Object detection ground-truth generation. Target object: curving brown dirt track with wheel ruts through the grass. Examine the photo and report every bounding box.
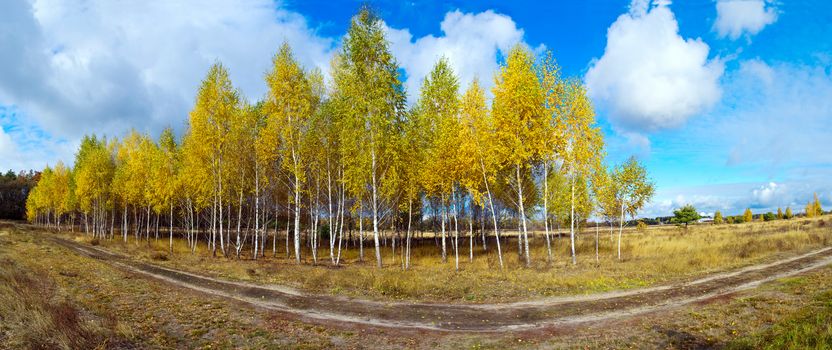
[46,228,832,332]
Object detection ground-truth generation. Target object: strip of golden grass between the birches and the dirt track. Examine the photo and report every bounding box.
[65,217,832,303]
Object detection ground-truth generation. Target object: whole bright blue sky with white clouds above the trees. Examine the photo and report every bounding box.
[0,0,832,216]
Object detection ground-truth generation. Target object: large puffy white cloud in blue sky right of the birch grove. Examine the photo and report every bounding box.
[585,0,724,132]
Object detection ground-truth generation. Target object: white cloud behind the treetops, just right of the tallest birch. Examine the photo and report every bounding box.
[387,10,523,102]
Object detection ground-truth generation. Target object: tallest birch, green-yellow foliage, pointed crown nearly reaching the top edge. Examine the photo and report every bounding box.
[334,7,405,267]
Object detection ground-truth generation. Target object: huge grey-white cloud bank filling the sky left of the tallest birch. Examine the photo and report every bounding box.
[0,0,334,160]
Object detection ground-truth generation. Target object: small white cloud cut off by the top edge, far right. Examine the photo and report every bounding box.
[714,0,777,40]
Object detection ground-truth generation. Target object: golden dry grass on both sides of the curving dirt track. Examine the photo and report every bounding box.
[0,217,832,349]
